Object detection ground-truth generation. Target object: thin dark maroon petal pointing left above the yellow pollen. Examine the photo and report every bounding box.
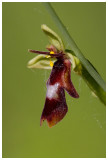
[28,49,65,57]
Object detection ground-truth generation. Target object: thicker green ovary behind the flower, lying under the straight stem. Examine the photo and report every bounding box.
[65,49,106,105]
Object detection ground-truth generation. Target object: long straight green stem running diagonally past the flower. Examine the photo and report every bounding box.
[43,2,106,92]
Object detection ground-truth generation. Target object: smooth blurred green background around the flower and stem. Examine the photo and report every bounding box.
[2,2,106,158]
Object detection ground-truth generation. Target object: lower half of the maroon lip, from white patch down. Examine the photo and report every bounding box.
[40,84,68,127]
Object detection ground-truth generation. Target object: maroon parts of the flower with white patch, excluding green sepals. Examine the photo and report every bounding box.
[29,46,79,127]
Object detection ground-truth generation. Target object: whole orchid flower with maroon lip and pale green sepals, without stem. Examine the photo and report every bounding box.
[28,25,79,127]
